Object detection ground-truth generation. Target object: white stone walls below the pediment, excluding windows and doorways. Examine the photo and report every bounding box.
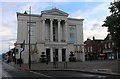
[17,9,84,63]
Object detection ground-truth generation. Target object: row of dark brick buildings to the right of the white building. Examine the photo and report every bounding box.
[84,34,119,60]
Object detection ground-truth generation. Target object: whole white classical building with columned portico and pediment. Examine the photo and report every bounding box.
[16,8,84,63]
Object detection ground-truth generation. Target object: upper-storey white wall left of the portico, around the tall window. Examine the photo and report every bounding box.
[17,14,42,43]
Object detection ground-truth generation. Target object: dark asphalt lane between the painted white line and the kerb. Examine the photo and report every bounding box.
[34,71,120,79]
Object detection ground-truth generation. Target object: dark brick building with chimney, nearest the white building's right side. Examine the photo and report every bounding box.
[84,37,103,60]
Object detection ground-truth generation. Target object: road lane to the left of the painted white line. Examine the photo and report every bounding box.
[2,63,52,79]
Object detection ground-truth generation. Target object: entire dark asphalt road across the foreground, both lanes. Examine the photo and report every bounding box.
[0,63,119,79]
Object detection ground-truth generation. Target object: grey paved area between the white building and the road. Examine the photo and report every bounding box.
[7,60,120,76]
